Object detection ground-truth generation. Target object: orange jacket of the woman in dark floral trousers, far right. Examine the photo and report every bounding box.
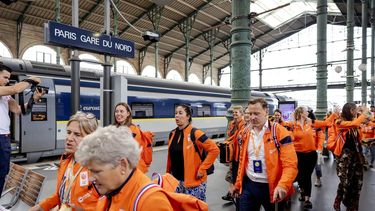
[328,114,366,156]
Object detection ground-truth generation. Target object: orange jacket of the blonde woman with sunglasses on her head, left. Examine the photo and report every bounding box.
[39,155,99,210]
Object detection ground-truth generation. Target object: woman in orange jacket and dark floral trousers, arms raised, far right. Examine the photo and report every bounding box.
[330,103,371,211]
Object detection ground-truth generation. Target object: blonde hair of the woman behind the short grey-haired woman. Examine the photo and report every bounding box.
[67,111,98,135]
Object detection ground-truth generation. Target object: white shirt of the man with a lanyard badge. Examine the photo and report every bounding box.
[246,120,268,183]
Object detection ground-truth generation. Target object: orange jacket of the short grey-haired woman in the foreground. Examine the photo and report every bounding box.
[96,169,173,211]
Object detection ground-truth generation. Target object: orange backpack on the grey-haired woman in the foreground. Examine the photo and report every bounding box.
[133,182,208,211]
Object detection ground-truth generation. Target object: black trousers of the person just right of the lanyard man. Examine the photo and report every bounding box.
[297,151,318,197]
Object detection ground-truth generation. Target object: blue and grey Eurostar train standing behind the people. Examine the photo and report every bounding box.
[0,57,288,162]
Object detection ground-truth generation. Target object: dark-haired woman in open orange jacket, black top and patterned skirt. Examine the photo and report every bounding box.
[166,105,220,201]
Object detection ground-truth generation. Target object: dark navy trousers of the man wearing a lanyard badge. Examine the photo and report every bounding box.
[240,176,285,211]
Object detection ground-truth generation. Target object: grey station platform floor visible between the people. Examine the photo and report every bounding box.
[0,146,375,211]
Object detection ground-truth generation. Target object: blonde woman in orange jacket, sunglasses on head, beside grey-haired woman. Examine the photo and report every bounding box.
[30,112,99,211]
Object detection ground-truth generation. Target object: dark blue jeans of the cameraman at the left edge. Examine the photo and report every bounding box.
[0,135,11,196]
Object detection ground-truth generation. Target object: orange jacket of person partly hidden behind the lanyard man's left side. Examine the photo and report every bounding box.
[226,118,245,162]
